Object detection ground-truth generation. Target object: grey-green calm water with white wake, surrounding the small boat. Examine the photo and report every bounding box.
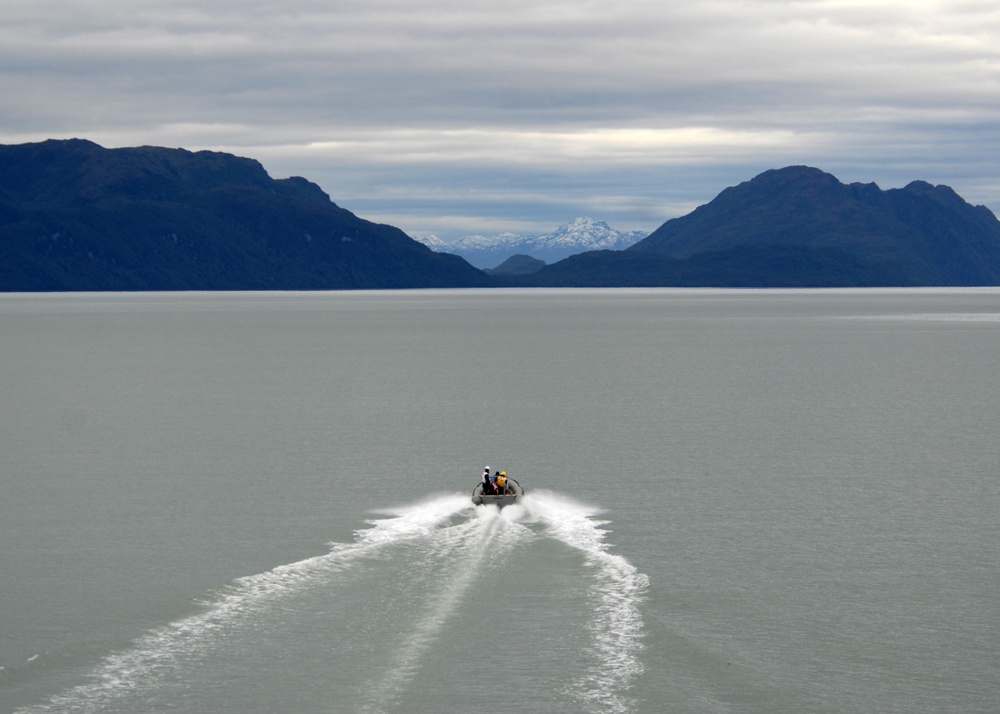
[0,289,1000,712]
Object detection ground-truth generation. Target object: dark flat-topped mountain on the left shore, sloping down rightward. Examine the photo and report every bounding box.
[0,139,490,291]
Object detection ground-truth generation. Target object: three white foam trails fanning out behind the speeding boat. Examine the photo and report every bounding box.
[20,491,648,714]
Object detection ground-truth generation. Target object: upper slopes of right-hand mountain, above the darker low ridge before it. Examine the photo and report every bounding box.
[628,166,1000,285]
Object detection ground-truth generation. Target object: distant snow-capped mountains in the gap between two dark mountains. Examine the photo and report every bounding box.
[417,218,648,268]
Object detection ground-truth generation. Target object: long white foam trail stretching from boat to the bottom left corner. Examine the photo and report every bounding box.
[17,495,471,714]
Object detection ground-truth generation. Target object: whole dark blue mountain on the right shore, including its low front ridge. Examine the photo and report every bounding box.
[528,166,1000,287]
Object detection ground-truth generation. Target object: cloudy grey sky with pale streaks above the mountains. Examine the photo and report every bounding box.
[0,0,1000,240]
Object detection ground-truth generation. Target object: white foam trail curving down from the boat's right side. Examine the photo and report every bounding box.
[524,491,649,712]
